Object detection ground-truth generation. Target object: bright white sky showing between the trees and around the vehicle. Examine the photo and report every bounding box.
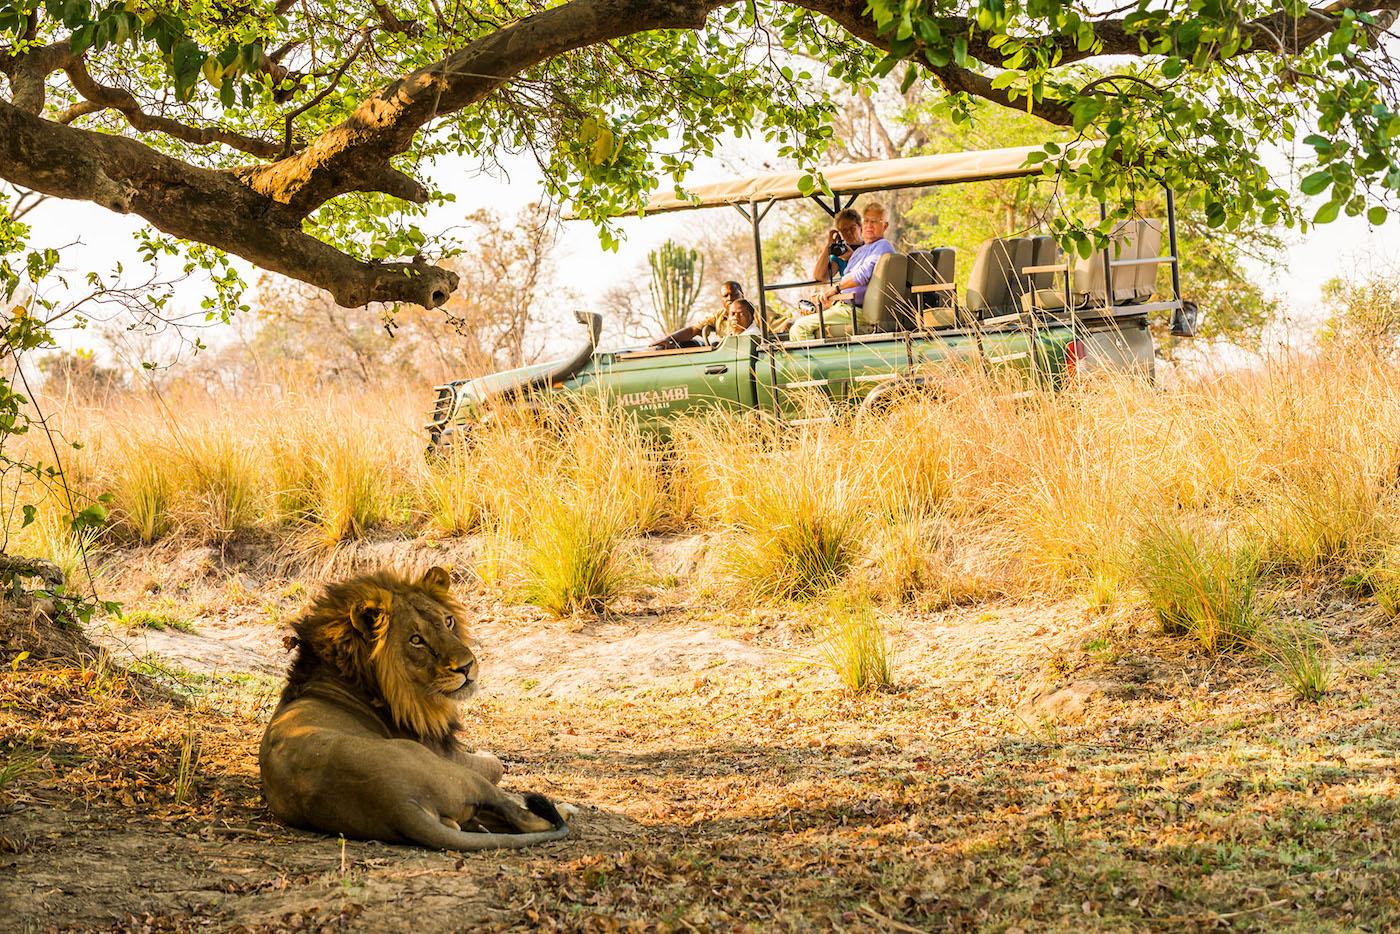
[27,140,1400,369]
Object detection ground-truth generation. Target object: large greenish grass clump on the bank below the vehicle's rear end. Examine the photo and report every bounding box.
[1137,521,1260,653]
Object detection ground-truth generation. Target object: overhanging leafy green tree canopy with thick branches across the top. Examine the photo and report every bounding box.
[0,0,1400,313]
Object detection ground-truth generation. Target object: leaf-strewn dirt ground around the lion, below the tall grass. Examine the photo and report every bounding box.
[0,537,1400,934]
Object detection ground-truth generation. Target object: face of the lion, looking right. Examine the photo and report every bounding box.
[375,590,477,700]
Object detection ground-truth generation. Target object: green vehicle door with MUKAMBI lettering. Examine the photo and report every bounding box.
[603,337,752,424]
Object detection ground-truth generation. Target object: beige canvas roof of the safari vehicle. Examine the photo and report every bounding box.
[618,146,1040,214]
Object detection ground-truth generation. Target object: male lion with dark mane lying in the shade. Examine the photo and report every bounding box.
[258,567,568,850]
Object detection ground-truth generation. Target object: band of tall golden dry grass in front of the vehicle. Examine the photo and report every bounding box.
[8,358,1400,632]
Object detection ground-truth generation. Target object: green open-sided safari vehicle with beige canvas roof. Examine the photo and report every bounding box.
[427,147,1196,447]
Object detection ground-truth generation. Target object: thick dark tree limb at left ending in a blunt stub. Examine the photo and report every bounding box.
[0,101,456,308]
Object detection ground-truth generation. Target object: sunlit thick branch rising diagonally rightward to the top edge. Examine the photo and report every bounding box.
[242,0,722,216]
